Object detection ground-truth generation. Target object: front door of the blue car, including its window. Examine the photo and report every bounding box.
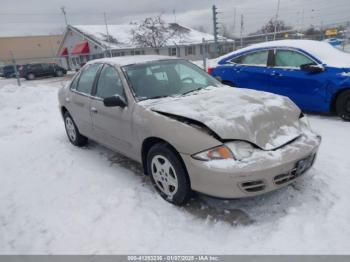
[267,49,330,112]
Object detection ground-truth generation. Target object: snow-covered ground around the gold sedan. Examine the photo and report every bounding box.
[0,78,350,254]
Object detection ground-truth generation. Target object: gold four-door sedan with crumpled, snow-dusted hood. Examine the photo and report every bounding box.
[59,56,321,205]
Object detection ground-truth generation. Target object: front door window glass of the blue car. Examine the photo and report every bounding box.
[275,50,315,68]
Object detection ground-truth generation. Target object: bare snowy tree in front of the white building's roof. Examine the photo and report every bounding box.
[131,15,189,48]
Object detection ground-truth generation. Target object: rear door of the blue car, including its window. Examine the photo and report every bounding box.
[213,49,272,90]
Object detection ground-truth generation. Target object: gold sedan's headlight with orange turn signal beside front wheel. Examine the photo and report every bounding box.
[192,141,257,161]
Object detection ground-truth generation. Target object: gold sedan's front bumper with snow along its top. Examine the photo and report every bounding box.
[181,132,321,198]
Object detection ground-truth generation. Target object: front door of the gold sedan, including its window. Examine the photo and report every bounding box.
[90,65,137,158]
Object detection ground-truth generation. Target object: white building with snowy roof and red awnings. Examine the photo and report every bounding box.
[58,23,234,68]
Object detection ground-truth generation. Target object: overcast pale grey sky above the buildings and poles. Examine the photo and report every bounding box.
[0,0,350,37]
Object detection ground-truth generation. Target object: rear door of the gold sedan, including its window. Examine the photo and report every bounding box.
[66,64,102,137]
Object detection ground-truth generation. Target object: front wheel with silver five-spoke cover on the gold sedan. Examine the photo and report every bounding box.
[147,143,192,206]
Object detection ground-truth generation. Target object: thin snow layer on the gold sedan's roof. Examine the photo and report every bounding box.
[88,55,177,66]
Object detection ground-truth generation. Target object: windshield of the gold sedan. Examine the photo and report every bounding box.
[123,59,220,101]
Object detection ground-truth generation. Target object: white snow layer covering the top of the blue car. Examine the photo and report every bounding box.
[215,40,350,67]
